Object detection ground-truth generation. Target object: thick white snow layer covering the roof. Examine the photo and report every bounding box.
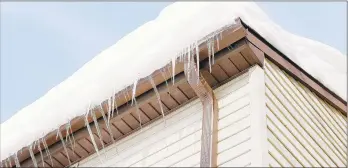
[1,2,347,160]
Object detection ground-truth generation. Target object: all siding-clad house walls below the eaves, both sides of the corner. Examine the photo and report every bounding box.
[75,61,347,167]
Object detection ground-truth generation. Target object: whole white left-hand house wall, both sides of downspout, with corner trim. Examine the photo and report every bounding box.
[79,67,267,167]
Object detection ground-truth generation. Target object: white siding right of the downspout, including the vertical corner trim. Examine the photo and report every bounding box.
[215,66,267,167]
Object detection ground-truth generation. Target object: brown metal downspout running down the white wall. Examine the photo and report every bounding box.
[184,56,218,167]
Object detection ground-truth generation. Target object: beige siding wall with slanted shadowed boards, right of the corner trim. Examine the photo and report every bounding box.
[265,61,347,167]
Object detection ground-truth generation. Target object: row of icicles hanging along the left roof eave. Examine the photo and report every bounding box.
[2,25,231,167]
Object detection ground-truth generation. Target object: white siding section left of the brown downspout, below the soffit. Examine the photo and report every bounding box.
[79,100,202,167]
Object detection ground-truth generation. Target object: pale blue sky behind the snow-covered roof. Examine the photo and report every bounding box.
[0,2,347,123]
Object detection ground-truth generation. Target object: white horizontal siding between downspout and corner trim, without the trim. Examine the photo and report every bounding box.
[215,73,251,167]
